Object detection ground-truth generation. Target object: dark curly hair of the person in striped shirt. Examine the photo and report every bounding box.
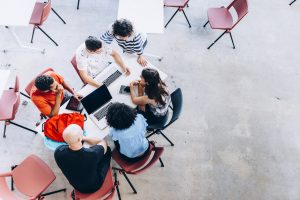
[113,19,133,37]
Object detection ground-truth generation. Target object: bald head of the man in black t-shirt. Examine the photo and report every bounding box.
[63,124,83,145]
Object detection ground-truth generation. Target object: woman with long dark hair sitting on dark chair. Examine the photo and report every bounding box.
[130,68,171,125]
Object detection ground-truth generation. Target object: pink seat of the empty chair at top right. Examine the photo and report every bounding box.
[207,8,233,30]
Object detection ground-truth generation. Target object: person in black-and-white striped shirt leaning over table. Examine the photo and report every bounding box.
[100,19,147,67]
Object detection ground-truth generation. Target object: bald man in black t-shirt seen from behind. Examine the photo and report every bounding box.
[54,124,111,193]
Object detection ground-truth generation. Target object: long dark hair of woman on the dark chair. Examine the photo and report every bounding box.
[142,68,169,106]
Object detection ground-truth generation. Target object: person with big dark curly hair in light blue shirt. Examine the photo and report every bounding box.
[106,103,149,162]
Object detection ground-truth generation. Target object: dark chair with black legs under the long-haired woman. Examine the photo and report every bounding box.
[147,88,183,146]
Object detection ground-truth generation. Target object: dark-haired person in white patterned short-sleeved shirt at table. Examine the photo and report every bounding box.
[76,36,130,87]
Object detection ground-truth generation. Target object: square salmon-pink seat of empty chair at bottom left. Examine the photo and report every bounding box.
[12,155,56,197]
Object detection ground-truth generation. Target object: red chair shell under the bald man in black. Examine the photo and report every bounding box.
[75,168,114,200]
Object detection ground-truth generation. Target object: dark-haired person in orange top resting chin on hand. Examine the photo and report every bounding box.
[30,71,82,117]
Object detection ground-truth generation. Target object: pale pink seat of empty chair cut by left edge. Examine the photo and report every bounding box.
[0,89,17,121]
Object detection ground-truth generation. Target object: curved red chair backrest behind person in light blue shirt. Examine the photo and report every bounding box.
[112,143,164,174]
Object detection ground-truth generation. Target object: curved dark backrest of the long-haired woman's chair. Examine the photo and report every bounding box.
[165,88,183,128]
